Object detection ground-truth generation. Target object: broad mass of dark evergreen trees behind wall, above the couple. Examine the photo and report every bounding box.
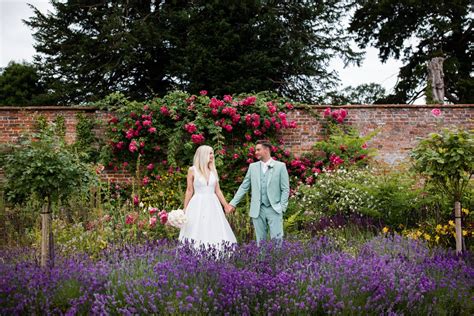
[26,0,361,102]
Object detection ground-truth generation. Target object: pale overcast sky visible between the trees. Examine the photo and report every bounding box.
[0,0,402,100]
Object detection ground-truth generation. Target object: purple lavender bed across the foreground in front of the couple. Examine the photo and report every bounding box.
[0,235,474,315]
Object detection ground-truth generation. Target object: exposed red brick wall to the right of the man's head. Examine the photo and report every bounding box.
[283,104,474,164]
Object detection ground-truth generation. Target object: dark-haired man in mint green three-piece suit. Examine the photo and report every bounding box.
[226,140,290,244]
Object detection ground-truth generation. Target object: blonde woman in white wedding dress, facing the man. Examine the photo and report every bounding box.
[179,145,237,248]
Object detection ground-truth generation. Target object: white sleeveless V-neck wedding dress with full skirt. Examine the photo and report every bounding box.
[179,167,237,249]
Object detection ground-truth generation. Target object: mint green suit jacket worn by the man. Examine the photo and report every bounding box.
[230,160,290,218]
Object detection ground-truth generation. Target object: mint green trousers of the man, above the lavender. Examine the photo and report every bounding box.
[252,204,283,244]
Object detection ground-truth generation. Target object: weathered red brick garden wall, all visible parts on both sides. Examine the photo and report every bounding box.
[0,104,474,181]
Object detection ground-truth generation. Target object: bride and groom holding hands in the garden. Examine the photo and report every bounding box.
[179,140,290,247]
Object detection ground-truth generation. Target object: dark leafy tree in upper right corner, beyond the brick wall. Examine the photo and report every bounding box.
[349,0,474,103]
